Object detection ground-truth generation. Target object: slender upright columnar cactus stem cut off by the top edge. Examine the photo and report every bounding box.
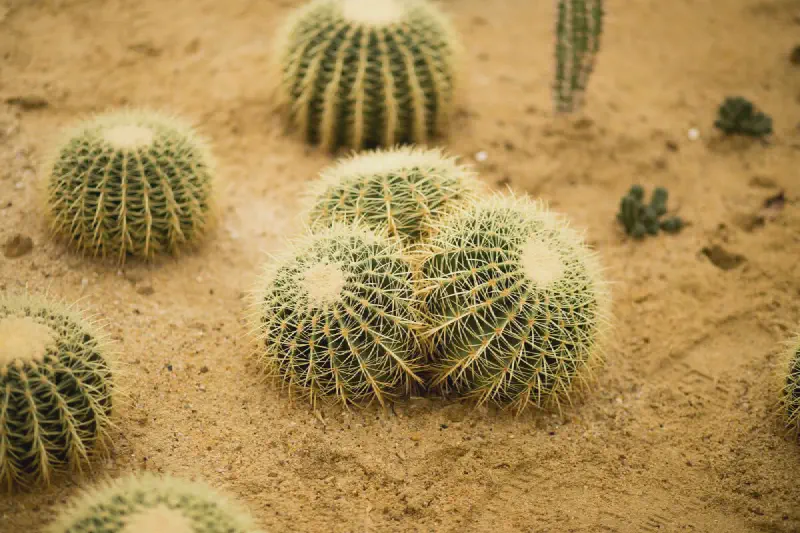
[553,0,604,113]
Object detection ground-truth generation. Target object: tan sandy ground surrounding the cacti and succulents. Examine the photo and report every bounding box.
[0,0,800,533]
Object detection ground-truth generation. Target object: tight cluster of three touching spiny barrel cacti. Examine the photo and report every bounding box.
[253,148,609,410]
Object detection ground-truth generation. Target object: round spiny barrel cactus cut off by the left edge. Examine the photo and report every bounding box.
[0,295,113,489]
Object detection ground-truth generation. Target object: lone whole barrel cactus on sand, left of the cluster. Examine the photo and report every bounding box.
[47,111,212,262]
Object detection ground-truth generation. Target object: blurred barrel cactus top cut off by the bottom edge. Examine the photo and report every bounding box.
[46,474,256,533]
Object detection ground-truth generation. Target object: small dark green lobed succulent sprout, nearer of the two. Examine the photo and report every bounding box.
[617,185,686,239]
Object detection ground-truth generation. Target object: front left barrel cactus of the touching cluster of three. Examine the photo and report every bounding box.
[254,225,420,405]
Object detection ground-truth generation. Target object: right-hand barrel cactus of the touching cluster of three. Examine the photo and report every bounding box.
[421,197,609,411]
